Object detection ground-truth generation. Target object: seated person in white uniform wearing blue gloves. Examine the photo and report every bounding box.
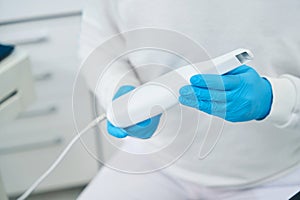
[79,0,300,200]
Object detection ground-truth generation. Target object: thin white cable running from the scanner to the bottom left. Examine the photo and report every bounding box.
[17,114,106,200]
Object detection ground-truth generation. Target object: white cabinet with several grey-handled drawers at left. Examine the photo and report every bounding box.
[0,0,99,195]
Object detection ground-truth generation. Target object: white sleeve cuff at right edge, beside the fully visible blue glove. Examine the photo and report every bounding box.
[265,75,300,130]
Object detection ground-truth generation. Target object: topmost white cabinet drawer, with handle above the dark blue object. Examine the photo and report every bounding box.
[0,15,80,74]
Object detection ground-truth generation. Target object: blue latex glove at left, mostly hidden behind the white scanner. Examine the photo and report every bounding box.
[107,85,161,139]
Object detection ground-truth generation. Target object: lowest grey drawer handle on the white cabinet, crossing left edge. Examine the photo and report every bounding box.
[0,135,64,154]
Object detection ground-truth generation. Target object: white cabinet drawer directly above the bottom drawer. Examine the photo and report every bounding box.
[0,86,92,138]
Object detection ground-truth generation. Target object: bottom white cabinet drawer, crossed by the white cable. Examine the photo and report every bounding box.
[0,122,98,195]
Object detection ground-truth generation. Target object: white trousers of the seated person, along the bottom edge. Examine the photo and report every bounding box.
[78,167,300,200]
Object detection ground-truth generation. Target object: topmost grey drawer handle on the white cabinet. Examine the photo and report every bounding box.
[1,30,49,45]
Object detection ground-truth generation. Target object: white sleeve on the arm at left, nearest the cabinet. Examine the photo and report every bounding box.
[79,0,140,111]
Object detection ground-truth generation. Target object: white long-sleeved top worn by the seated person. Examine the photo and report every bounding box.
[80,0,300,187]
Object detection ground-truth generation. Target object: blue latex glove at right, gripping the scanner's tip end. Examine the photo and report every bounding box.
[179,65,273,122]
